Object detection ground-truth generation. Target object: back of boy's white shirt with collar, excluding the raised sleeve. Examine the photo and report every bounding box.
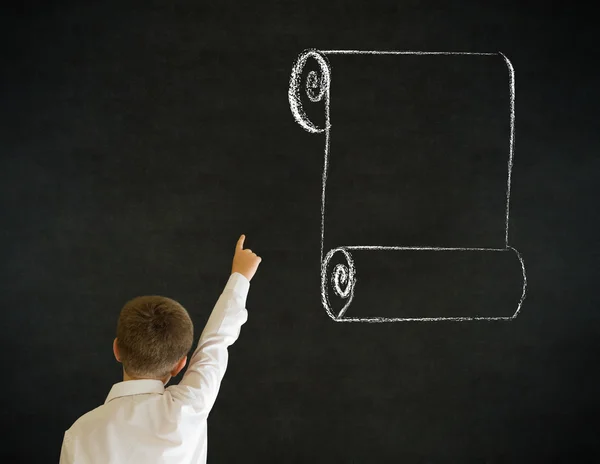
[61,380,212,463]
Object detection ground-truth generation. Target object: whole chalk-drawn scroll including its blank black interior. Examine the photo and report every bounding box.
[288,50,527,322]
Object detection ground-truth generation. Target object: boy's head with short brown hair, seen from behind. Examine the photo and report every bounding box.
[113,296,194,383]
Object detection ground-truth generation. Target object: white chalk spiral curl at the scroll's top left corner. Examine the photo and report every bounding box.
[288,50,331,133]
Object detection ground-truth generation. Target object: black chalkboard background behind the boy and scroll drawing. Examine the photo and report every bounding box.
[0,1,600,463]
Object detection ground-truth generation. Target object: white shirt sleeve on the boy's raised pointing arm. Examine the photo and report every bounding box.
[167,272,250,416]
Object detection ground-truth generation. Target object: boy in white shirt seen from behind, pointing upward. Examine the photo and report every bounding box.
[60,235,262,464]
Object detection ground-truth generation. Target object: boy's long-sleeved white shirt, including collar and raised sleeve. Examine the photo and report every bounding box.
[60,272,250,464]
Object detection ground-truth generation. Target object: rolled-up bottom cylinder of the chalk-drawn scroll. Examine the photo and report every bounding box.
[321,247,526,322]
